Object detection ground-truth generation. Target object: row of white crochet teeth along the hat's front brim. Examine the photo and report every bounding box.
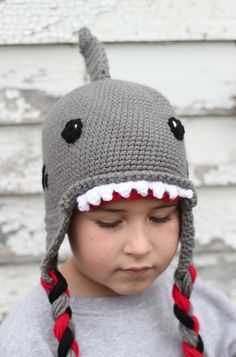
[76,180,193,211]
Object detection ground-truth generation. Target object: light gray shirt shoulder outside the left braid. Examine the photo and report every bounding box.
[0,284,55,357]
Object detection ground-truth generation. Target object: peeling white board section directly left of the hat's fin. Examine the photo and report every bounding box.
[0,45,85,124]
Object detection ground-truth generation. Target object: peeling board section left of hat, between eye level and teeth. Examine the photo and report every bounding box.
[0,125,43,194]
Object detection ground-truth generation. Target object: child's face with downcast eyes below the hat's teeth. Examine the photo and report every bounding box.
[69,199,180,296]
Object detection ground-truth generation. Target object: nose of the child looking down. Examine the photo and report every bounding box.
[123,229,152,257]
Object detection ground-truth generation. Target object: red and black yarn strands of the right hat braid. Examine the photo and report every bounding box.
[172,264,204,357]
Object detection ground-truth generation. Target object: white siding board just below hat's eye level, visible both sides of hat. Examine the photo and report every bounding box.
[0,117,236,195]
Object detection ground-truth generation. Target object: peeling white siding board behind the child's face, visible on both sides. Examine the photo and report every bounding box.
[0,187,236,266]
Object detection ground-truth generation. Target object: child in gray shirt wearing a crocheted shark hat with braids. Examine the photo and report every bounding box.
[0,28,236,357]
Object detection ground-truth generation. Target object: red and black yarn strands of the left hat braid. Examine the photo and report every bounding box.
[40,269,79,357]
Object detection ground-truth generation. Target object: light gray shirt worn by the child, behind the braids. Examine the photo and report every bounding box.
[0,267,236,357]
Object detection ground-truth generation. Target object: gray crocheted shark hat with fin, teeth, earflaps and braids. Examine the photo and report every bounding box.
[41,27,203,357]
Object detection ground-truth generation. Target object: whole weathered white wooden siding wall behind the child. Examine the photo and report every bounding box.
[0,0,236,320]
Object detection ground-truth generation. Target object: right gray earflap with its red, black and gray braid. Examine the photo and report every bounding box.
[172,199,204,357]
